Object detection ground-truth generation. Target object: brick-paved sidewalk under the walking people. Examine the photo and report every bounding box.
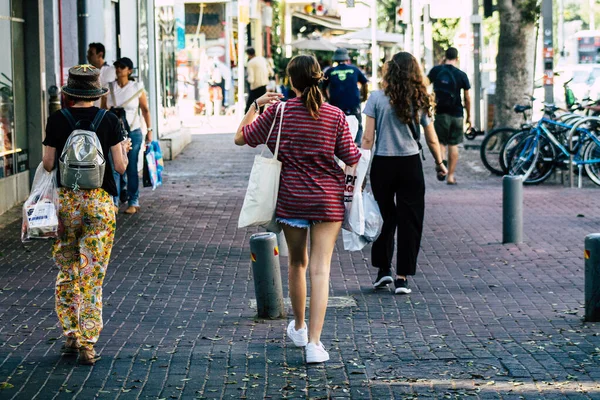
[0,133,600,400]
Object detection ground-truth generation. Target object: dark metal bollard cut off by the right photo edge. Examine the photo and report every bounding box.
[583,233,600,322]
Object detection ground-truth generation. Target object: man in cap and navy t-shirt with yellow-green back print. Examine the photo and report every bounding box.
[323,48,368,146]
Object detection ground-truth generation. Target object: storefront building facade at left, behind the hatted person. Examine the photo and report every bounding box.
[0,0,180,214]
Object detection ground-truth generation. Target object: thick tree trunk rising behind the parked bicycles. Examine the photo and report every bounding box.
[494,0,536,128]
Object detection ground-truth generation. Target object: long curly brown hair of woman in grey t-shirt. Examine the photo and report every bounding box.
[383,51,435,124]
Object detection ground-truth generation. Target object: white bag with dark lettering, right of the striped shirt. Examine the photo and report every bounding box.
[342,149,371,235]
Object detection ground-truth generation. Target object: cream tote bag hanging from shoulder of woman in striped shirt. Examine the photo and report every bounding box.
[238,102,285,228]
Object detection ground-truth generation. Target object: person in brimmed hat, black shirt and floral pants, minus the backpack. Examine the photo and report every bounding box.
[43,65,131,365]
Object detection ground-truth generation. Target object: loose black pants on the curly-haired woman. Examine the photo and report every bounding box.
[370,154,425,275]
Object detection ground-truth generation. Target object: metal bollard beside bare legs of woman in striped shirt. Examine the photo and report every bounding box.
[250,232,285,319]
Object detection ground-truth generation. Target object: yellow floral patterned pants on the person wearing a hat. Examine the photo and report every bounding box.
[52,188,116,348]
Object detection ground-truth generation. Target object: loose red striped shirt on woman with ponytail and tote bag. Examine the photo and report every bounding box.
[243,97,360,221]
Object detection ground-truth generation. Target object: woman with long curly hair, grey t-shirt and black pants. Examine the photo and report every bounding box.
[362,52,447,294]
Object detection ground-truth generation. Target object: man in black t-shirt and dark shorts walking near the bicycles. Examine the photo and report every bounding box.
[428,47,471,185]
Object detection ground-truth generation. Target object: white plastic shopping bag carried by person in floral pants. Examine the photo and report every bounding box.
[21,163,59,242]
